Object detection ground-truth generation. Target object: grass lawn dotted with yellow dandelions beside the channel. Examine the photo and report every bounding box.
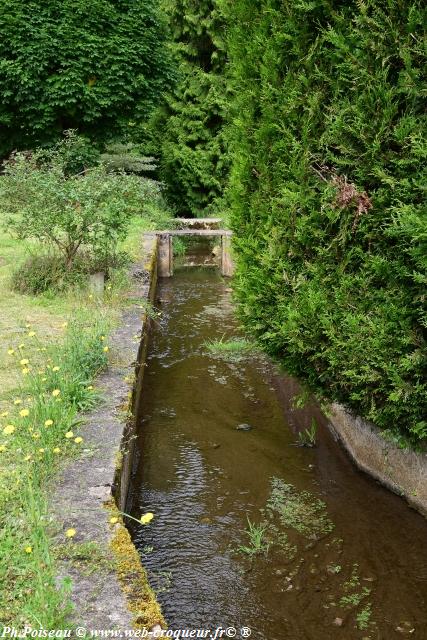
[0,218,166,629]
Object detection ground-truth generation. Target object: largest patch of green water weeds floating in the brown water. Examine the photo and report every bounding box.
[267,478,334,539]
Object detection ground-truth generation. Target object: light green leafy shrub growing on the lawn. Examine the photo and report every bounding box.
[0,135,144,271]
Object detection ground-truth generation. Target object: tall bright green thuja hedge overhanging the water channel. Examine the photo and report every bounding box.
[223,0,427,443]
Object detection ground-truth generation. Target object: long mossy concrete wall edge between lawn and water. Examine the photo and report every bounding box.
[49,234,166,635]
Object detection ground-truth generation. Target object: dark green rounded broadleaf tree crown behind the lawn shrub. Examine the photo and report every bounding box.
[0,0,174,156]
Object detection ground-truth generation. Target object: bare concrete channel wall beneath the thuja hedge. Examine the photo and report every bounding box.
[328,403,427,517]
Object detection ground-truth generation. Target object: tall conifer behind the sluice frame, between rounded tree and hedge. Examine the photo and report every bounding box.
[155,0,228,216]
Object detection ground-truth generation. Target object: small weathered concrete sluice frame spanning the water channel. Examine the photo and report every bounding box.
[150,218,234,278]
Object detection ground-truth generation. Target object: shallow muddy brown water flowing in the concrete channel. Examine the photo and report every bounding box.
[128,268,427,640]
